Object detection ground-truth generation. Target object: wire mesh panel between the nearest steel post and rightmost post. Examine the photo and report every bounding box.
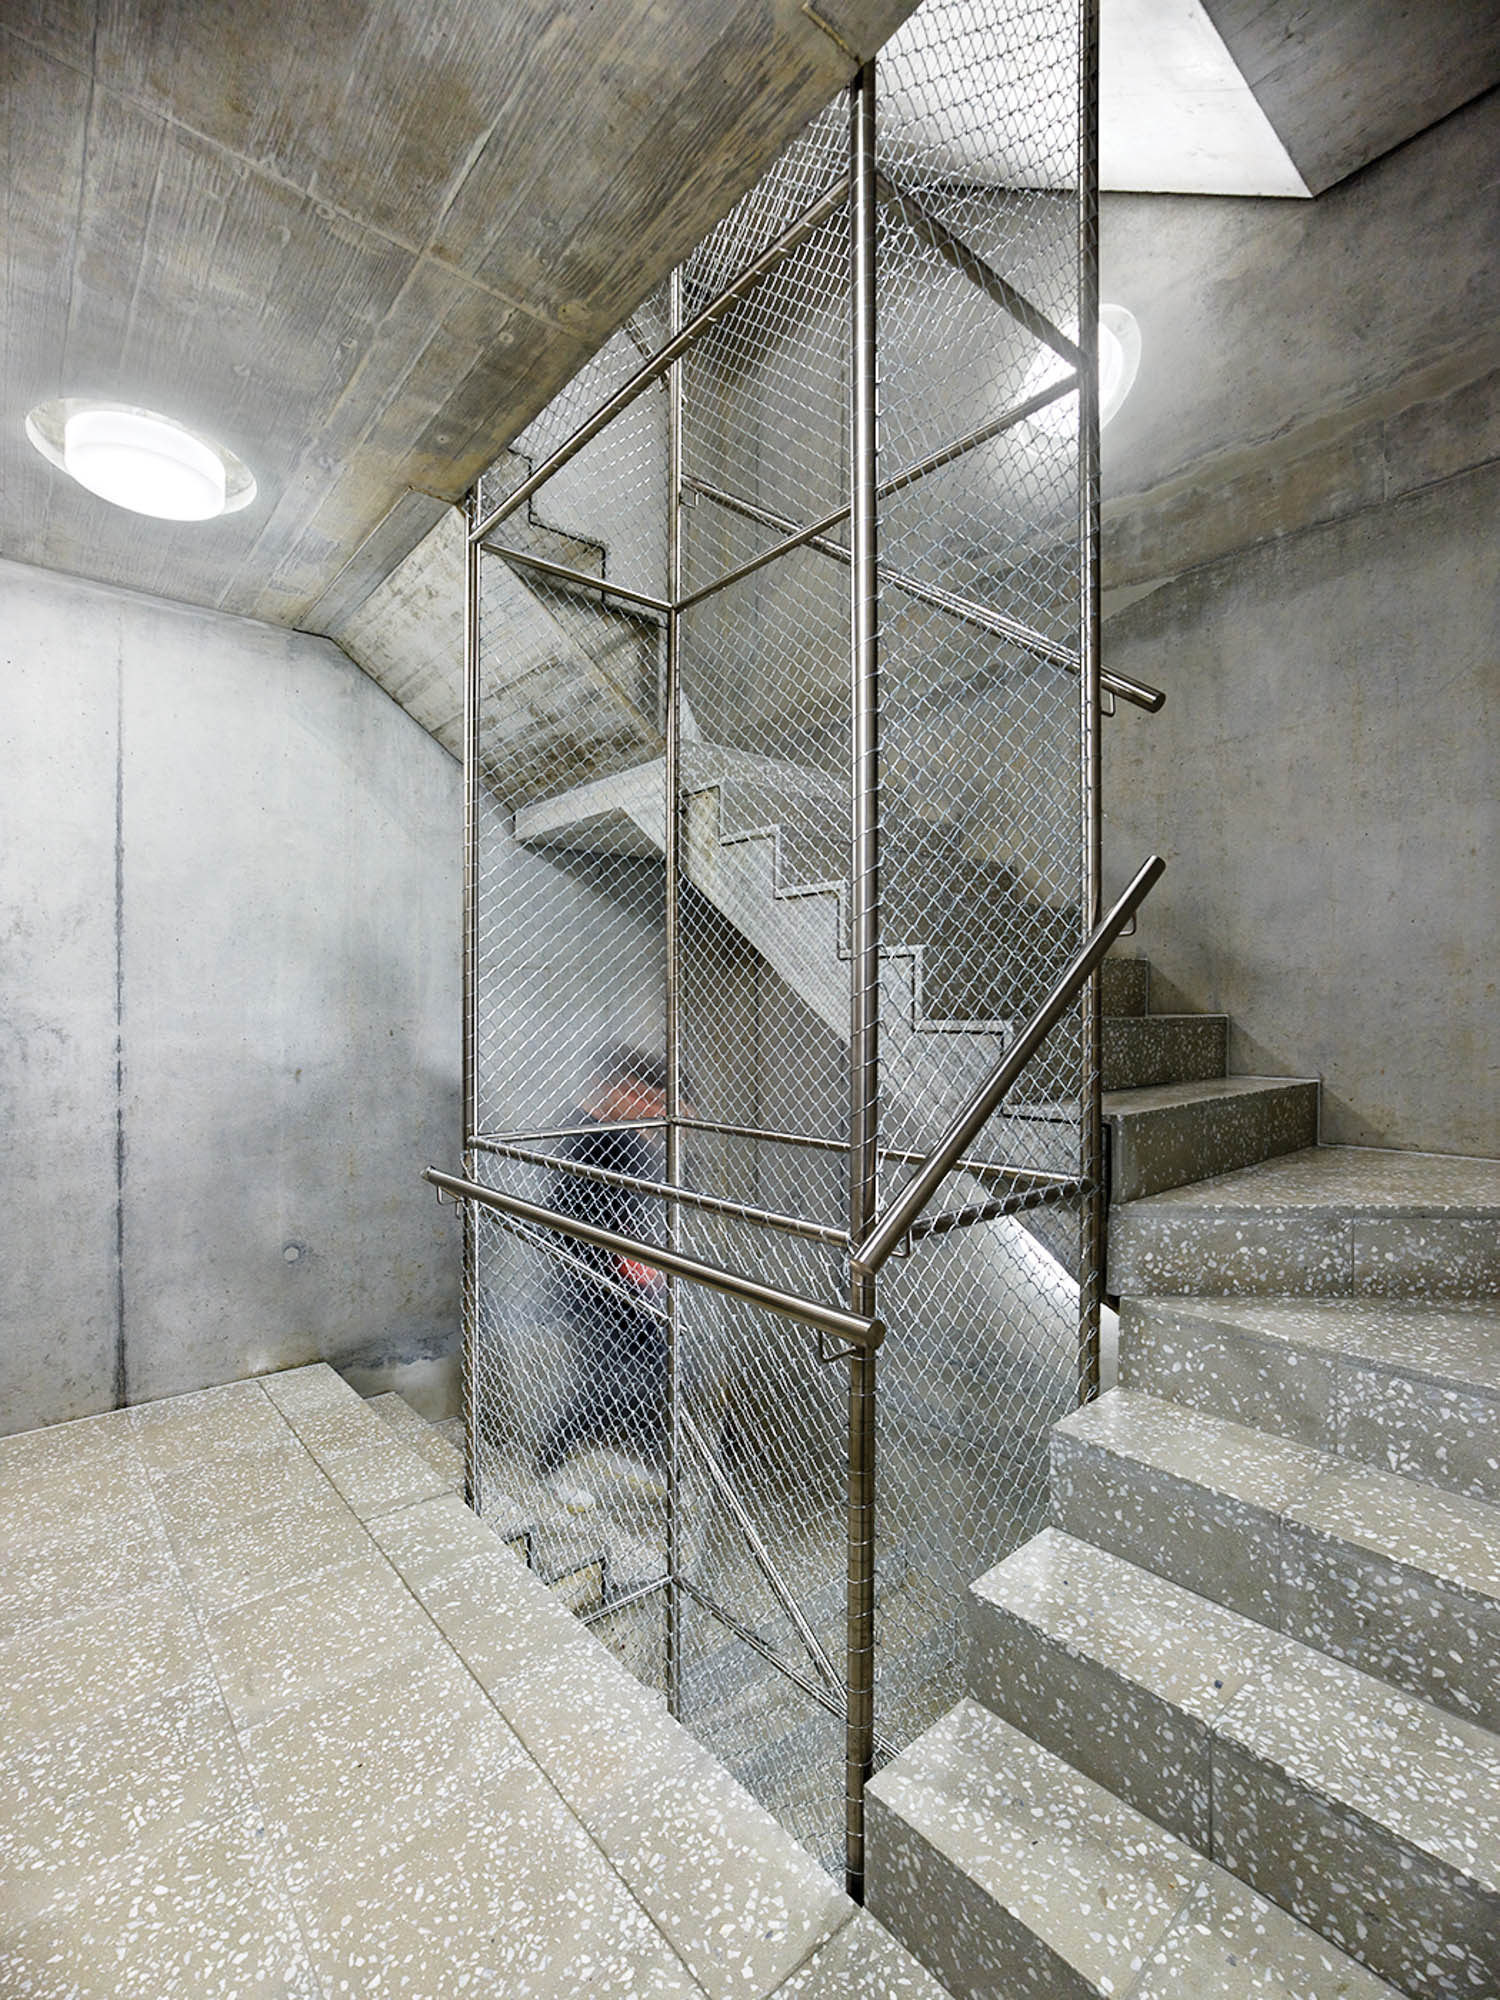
[876,0,1090,1784]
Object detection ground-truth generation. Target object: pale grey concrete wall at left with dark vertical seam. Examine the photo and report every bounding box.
[0,564,460,1430]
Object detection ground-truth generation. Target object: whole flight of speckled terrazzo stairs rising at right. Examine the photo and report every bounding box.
[856,964,1500,2000]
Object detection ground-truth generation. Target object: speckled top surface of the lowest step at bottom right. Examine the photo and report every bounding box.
[870,1702,1392,2000]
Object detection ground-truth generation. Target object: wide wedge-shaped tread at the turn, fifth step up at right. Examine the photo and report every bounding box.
[1106,1144,1500,1216]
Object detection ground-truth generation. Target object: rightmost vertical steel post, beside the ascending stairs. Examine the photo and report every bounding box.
[1078,0,1108,1402]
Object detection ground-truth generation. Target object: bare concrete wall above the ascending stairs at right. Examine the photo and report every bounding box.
[1102,96,1500,1154]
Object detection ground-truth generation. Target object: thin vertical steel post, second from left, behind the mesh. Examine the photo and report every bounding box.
[662,270,682,1716]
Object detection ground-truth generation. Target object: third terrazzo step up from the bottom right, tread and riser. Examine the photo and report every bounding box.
[1052,1388,1500,1728]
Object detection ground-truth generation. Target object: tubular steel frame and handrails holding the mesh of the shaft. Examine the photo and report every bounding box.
[456,0,1136,1898]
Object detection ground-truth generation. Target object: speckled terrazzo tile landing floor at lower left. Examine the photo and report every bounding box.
[0,1366,940,2000]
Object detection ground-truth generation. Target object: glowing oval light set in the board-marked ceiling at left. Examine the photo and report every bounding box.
[26,396,256,520]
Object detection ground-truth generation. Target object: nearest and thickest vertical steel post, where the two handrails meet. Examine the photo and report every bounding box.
[844,62,880,1902]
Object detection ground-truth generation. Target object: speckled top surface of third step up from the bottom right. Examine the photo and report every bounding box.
[1056,1388,1500,1602]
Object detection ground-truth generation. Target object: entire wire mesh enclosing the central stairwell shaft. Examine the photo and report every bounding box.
[468,0,1098,1868]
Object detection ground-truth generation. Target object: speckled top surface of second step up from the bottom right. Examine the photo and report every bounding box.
[972,1528,1500,1894]
